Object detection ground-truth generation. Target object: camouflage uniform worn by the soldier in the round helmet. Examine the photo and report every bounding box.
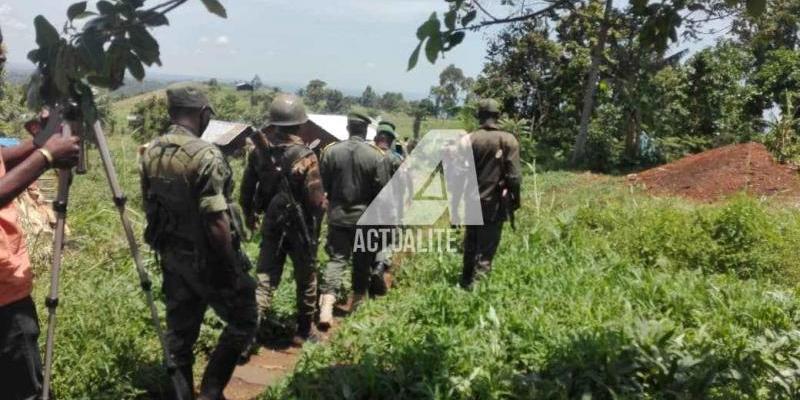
[241,134,326,334]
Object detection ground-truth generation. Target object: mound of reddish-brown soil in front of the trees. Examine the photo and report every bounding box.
[629,143,800,202]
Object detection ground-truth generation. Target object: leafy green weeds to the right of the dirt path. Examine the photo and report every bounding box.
[264,173,800,399]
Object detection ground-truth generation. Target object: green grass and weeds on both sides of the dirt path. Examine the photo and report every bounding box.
[34,118,800,399]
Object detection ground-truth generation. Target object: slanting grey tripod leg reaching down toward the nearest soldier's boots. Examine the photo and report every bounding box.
[92,122,194,400]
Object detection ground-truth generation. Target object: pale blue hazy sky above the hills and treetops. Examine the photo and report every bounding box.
[0,0,500,97]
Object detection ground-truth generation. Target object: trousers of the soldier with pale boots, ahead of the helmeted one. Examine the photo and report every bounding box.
[320,225,375,295]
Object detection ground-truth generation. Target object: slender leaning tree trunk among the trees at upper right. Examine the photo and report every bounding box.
[572,0,613,165]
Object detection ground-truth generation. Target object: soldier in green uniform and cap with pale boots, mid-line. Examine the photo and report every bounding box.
[319,113,388,329]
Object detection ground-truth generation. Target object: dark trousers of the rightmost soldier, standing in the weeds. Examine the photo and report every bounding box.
[460,221,503,288]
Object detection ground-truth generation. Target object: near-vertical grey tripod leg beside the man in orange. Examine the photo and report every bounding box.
[42,124,72,400]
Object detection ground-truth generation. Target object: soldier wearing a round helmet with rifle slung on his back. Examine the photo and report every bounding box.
[241,94,327,346]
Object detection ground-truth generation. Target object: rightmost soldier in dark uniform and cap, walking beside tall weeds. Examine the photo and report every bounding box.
[460,99,522,289]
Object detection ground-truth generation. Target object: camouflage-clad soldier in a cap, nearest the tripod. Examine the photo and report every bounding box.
[140,88,257,399]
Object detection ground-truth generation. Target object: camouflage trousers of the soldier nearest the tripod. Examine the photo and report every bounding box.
[159,247,258,398]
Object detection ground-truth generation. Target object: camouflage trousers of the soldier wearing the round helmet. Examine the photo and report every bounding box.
[256,228,317,320]
